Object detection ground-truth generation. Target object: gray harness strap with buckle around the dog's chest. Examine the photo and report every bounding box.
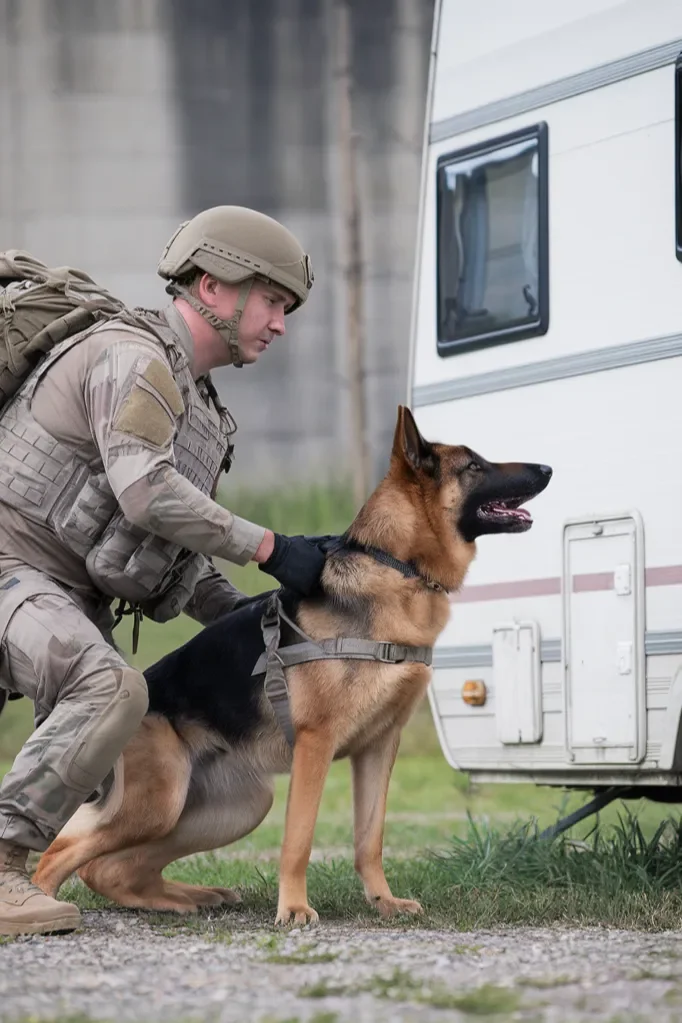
[252,592,434,746]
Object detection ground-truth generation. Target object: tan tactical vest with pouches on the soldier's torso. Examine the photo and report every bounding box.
[0,311,236,621]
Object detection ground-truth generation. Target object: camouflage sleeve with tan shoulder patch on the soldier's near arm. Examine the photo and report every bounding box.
[85,338,265,565]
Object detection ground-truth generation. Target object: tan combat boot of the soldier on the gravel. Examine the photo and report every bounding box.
[0,839,81,934]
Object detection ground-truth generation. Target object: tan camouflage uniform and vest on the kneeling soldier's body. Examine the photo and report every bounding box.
[0,307,265,850]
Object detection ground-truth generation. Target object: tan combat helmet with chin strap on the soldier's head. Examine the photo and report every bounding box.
[157,206,314,366]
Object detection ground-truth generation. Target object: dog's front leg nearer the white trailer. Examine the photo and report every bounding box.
[351,729,423,917]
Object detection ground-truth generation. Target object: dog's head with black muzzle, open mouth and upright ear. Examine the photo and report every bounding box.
[393,405,552,543]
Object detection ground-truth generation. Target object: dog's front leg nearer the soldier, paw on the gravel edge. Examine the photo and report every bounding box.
[275,730,334,924]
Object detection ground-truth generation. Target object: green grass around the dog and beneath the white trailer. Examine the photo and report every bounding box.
[0,487,682,932]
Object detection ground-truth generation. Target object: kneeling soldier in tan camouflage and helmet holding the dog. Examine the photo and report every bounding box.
[0,201,324,934]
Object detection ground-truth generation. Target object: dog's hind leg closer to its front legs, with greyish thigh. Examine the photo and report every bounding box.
[80,755,273,913]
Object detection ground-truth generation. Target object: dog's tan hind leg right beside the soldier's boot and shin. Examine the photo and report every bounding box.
[34,715,191,896]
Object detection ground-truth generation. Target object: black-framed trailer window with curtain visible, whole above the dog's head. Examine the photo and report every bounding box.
[438,123,549,355]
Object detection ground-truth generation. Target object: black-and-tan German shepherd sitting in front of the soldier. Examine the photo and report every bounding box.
[35,407,551,924]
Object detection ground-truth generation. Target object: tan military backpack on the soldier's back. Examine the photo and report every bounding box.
[0,249,126,414]
